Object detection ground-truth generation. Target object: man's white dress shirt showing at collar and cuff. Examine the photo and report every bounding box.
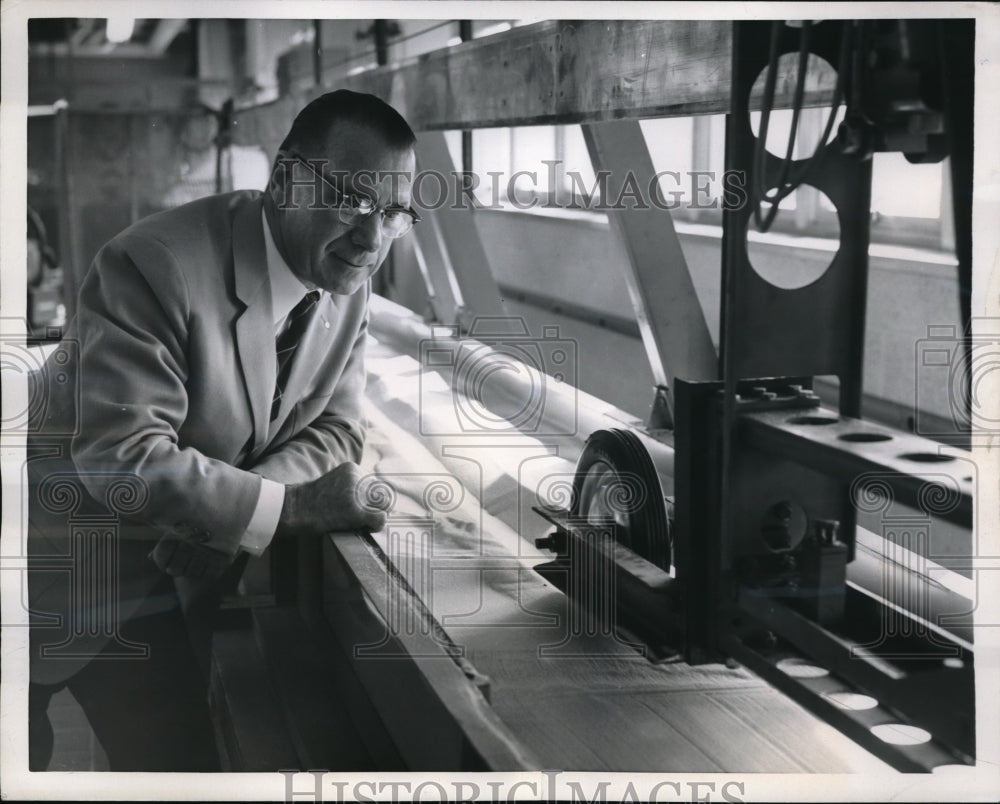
[240,209,322,556]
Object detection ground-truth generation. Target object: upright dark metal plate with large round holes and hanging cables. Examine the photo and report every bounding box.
[724,21,871,416]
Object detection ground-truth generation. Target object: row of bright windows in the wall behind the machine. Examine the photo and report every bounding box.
[468,109,953,250]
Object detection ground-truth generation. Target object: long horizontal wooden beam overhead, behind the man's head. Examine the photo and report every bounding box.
[237,20,832,149]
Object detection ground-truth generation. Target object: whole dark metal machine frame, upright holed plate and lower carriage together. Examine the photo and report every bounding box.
[532,21,976,771]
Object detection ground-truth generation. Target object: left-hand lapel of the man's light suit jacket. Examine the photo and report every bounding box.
[233,199,276,451]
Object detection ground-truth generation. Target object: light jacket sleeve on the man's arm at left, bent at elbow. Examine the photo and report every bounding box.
[72,234,260,555]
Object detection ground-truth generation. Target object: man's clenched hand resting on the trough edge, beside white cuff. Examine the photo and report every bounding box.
[277,463,394,536]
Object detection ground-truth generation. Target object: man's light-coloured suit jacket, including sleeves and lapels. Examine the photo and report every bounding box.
[27,191,370,675]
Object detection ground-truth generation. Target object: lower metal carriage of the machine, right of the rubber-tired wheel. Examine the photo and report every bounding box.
[674,379,975,771]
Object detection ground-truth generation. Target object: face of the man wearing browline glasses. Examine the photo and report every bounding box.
[272,122,415,295]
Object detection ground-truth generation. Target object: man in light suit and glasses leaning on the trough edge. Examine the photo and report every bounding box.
[28,90,419,770]
